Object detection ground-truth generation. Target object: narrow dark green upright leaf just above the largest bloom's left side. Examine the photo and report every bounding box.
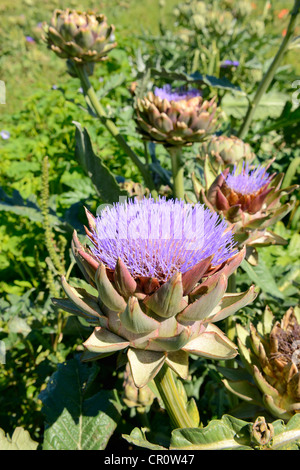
[73,121,127,204]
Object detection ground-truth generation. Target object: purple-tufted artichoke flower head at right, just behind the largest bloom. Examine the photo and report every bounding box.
[201,162,297,250]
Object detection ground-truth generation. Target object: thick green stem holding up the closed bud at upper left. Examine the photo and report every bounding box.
[76,65,155,191]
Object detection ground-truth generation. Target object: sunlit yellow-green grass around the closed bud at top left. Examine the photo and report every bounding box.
[0,0,178,116]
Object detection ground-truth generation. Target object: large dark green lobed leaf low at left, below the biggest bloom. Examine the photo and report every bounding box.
[39,356,120,450]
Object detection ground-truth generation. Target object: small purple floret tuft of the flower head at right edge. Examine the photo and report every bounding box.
[225,163,272,194]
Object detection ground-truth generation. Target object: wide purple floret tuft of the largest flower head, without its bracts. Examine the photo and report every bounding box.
[90,198,237,281]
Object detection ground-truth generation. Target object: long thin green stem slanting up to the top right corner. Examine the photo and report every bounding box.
[238,0,300,139]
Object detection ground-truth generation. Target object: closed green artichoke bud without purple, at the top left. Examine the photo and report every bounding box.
[45,9,116,63]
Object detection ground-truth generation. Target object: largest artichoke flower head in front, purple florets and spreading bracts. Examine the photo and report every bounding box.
[53,198,257,388]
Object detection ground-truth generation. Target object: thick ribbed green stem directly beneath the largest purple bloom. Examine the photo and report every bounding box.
[154,364,195,428]
